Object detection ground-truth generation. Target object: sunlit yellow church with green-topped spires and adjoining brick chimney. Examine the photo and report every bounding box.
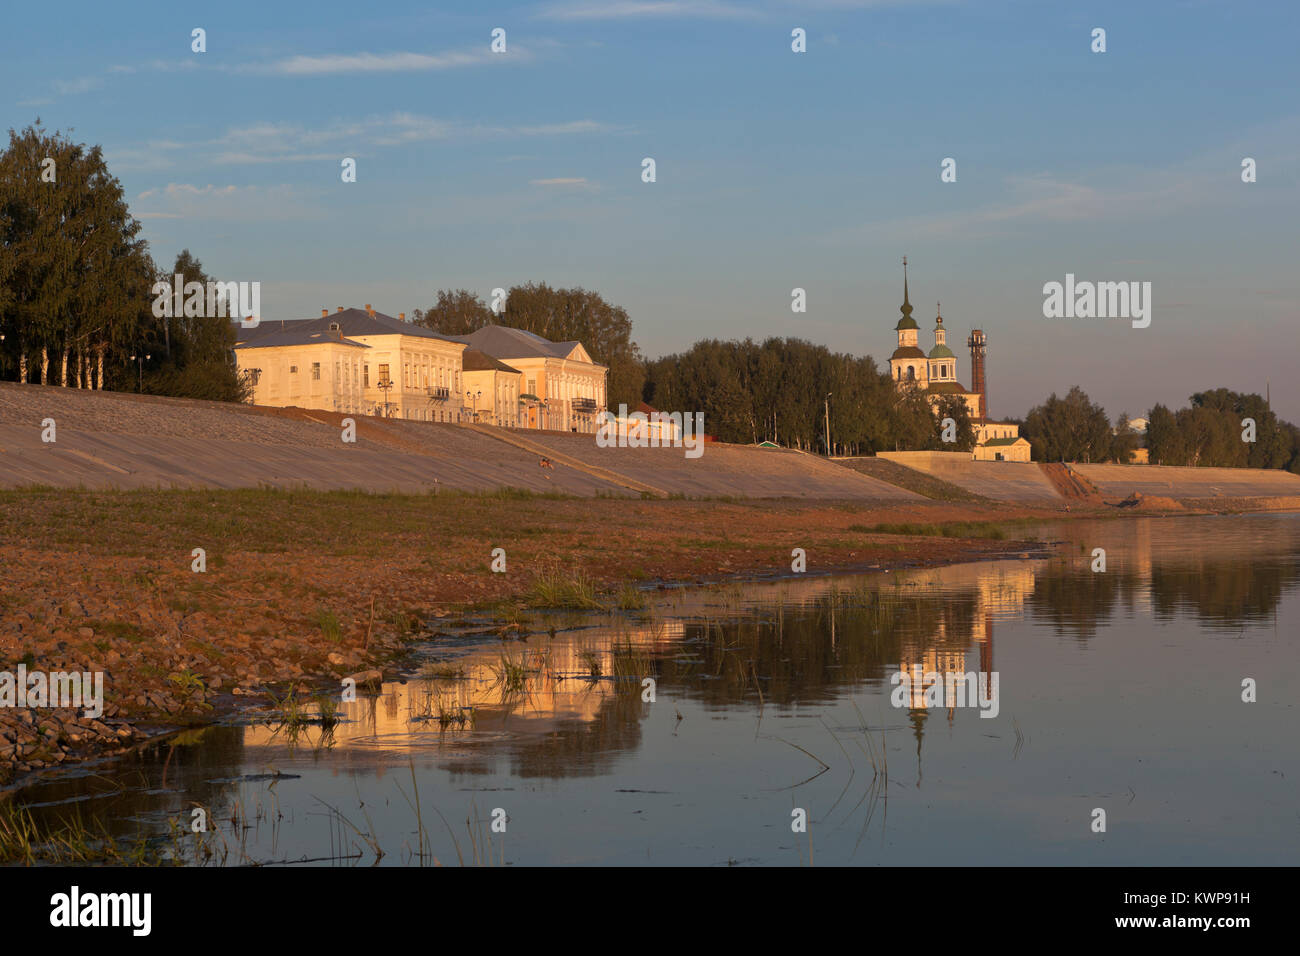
[889,256,1030,462]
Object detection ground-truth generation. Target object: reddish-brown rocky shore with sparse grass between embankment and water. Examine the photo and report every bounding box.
[0,489,1237,790]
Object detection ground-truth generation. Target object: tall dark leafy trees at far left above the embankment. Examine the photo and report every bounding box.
[0,118,246,401]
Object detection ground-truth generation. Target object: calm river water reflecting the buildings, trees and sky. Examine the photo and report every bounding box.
[12,515,1300,866]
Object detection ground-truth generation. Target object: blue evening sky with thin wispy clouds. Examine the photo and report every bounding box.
[0,0,1300,423]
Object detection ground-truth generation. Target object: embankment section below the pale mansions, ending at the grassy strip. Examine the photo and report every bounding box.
[0,384,922,501]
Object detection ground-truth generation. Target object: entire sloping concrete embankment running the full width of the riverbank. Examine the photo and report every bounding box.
[0,382,1300,510]
